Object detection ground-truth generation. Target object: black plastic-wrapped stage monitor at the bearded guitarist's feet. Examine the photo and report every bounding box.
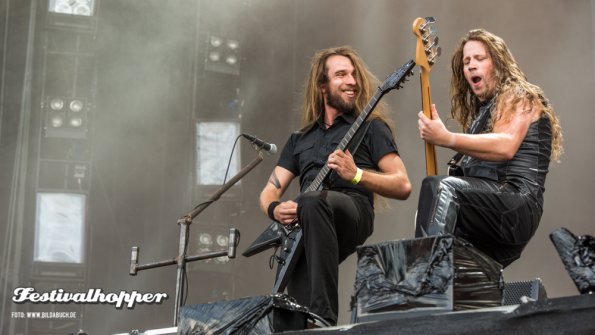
[178,294,309,335]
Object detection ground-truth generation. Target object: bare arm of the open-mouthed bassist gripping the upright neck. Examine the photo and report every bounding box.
[418,101,541,161]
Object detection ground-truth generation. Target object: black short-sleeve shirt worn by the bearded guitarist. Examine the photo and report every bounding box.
[277,115,398,205]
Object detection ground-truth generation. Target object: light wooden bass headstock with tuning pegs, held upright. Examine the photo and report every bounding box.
[413,17,441,72]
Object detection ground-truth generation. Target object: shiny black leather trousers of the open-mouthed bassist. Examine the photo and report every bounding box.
[415,176,542,267]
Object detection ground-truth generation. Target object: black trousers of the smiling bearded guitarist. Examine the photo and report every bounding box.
[287,190,374,325]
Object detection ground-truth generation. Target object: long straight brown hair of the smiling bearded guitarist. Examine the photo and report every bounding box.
[302,46,394,133]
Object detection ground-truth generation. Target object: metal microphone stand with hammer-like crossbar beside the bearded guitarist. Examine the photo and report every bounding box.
[130,150,263,326]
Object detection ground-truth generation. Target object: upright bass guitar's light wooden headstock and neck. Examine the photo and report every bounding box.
[413,17,440,176]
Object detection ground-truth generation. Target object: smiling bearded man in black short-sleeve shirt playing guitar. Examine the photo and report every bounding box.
[260,47,411,325]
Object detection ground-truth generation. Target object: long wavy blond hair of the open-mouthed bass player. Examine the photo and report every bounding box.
[450,29,563,160]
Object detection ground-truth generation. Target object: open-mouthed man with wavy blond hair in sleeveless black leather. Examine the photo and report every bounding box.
[416,29,562,266]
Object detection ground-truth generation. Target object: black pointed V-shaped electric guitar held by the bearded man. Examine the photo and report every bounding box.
[242,60,415,293]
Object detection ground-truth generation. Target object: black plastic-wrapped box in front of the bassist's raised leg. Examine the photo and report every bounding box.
[351,235,504,323]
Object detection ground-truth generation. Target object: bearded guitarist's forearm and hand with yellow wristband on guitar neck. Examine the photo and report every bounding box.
[328,150,411,200]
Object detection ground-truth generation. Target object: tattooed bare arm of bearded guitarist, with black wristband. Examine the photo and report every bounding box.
[260,166,297,224]
